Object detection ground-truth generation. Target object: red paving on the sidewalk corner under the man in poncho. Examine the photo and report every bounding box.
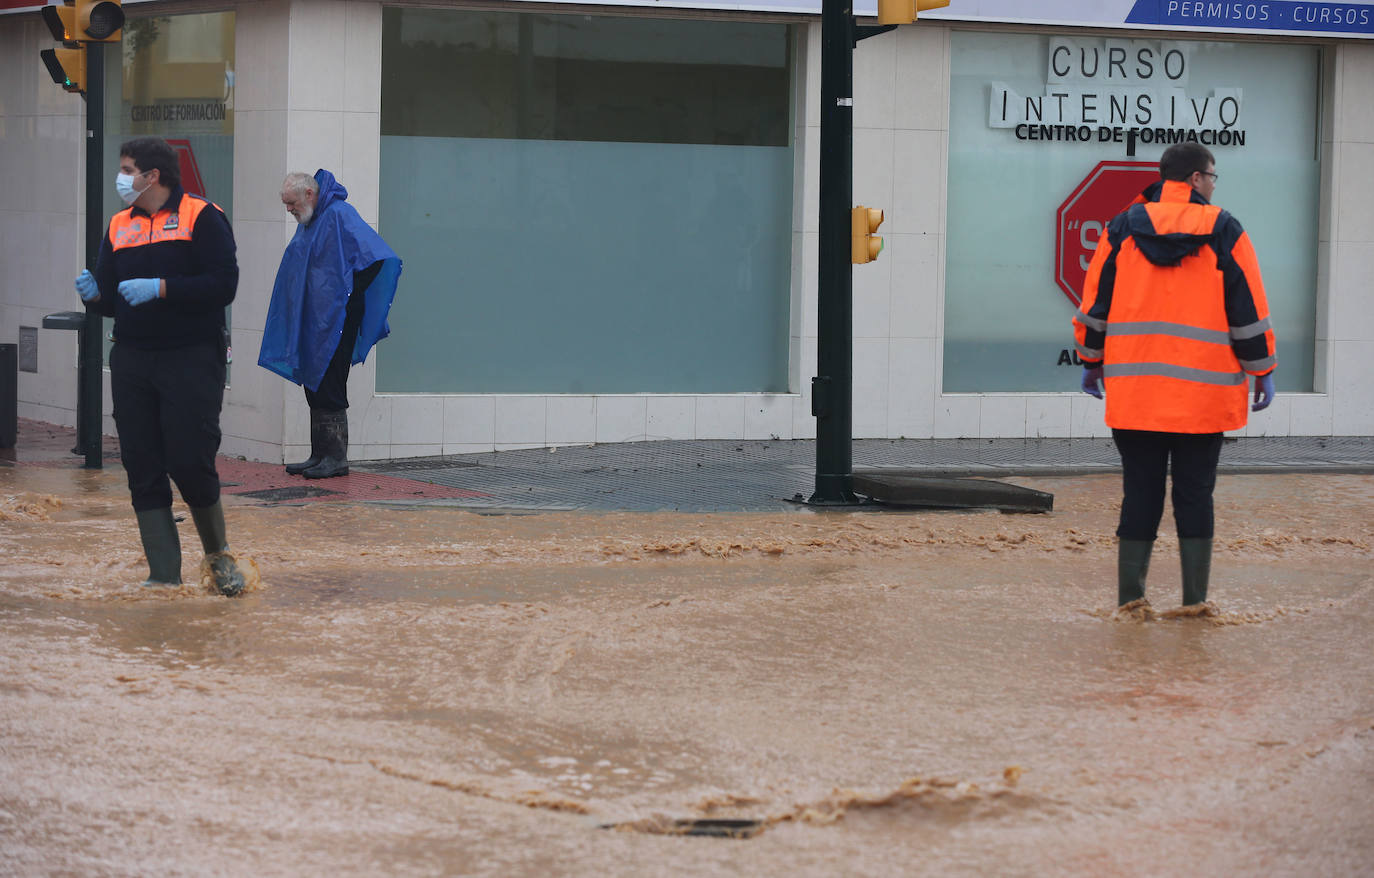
[0,418,491,506]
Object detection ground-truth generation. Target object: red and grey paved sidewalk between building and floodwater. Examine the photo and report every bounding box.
[0,419,1374,513]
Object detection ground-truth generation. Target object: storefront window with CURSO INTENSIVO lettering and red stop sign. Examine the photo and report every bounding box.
[944,32,1320,393]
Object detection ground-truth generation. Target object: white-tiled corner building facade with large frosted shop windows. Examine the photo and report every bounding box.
[0,0,1374,462]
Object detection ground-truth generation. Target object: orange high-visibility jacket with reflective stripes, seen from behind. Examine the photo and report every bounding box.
[1073,180,1276,433]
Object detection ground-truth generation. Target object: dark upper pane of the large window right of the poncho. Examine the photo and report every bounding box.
[382,8,790,147]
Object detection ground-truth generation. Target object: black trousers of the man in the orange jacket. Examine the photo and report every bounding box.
[1112,430,1221,540]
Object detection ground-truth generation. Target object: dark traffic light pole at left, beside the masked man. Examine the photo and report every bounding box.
[77,43,104,470]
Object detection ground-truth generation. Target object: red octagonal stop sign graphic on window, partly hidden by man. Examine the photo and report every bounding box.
[1054,162,1160,306]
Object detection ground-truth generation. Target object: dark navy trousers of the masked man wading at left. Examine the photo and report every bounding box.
[110,342,225,513]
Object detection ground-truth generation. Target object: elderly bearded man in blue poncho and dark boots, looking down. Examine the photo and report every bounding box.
[258,169,401,478]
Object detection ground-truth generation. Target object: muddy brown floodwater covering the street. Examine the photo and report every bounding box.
[0,467,1374,878]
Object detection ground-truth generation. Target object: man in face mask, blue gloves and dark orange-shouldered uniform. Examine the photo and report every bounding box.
[76,137,245,595]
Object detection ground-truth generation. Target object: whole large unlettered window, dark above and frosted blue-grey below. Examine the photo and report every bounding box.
[376,8,793,393]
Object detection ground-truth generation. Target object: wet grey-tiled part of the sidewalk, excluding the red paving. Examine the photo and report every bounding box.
[356,437,1374,513]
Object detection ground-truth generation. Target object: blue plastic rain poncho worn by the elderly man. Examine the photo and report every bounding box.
[258,169,401,390]
